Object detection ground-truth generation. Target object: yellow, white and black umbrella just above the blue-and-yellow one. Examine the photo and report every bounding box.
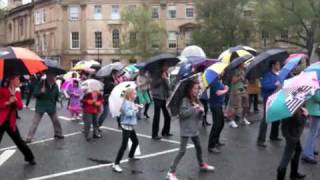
[218,45,257,64]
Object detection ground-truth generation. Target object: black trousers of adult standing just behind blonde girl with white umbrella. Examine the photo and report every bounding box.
[152,99,171,137]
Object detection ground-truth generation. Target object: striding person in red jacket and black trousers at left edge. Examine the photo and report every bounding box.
[0,76,36,165]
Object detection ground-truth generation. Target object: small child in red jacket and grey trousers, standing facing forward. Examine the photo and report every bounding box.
[82,91,103,141]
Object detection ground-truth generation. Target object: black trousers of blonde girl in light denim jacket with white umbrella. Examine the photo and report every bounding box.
[114,129,139,164]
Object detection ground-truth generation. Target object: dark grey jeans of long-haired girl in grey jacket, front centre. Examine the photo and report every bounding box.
[170,136,203,172]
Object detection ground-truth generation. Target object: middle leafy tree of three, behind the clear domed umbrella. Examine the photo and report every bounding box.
[192,0,254,56]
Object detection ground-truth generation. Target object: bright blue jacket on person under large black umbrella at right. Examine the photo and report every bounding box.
[260,71,280,99]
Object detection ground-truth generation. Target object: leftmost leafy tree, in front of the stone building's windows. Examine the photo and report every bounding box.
[120,4,164,58]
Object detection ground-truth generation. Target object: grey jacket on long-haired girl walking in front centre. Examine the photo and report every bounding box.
[179,97,203,137]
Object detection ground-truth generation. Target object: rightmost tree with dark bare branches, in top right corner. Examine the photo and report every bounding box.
[257,0,320,56]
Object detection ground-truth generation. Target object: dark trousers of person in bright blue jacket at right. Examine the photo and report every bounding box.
[258,99,280,142]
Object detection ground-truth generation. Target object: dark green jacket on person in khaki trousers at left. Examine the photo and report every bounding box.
[33,81,60,114]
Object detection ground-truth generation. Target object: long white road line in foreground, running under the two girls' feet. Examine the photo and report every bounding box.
[27,145,194,180]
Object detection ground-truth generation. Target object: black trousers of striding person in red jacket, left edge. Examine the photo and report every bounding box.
[0,120,34,161]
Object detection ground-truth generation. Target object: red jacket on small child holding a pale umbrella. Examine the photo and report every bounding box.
[81,93,103,114]
